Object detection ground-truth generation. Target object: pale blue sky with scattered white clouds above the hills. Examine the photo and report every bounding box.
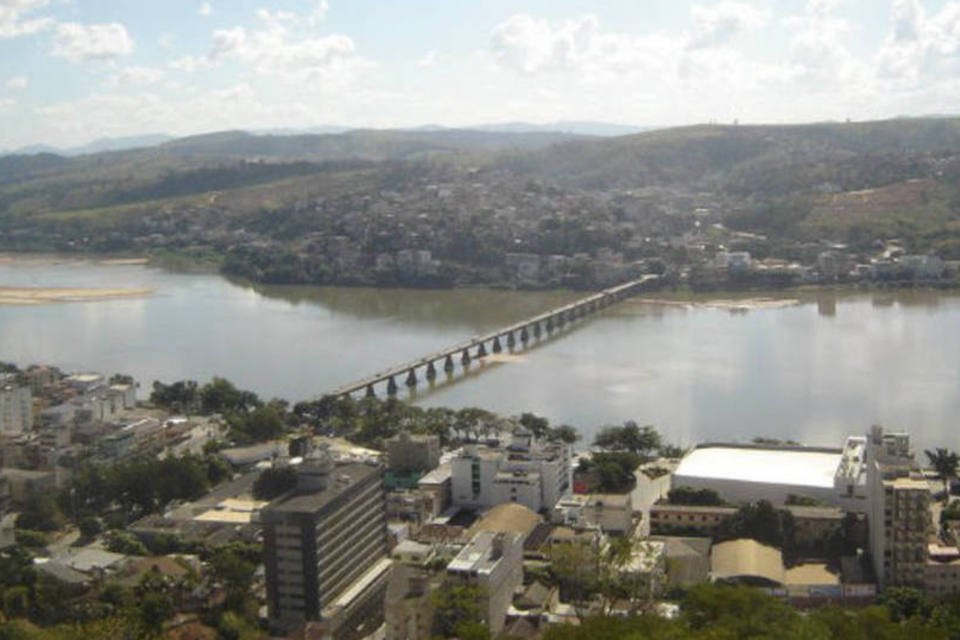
[0,0,960,149]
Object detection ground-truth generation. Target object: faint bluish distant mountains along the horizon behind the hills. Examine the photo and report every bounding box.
[0,121,655,158]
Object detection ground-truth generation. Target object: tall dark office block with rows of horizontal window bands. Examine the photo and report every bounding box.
[258,452,391,640]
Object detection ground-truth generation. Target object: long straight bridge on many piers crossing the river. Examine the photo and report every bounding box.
[326,275,659,396]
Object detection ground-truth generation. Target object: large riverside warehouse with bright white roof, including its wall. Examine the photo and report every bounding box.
[670,444,843,505]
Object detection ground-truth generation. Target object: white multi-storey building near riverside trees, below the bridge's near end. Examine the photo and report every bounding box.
[450,429,572,511]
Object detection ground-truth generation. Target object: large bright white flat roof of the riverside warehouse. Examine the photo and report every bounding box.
[674,446,841,488]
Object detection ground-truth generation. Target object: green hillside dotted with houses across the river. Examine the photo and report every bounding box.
[0,118,960,285]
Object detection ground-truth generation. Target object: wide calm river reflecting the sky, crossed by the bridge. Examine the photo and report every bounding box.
[0,260,960,448]
